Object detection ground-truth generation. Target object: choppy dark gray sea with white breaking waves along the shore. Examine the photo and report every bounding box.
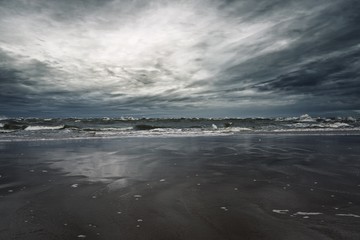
[0,115,360,141]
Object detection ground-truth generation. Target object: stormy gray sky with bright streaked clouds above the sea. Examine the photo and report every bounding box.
[0,0,360,117]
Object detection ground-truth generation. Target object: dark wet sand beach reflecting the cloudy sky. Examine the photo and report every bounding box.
[0,134,360,240]
